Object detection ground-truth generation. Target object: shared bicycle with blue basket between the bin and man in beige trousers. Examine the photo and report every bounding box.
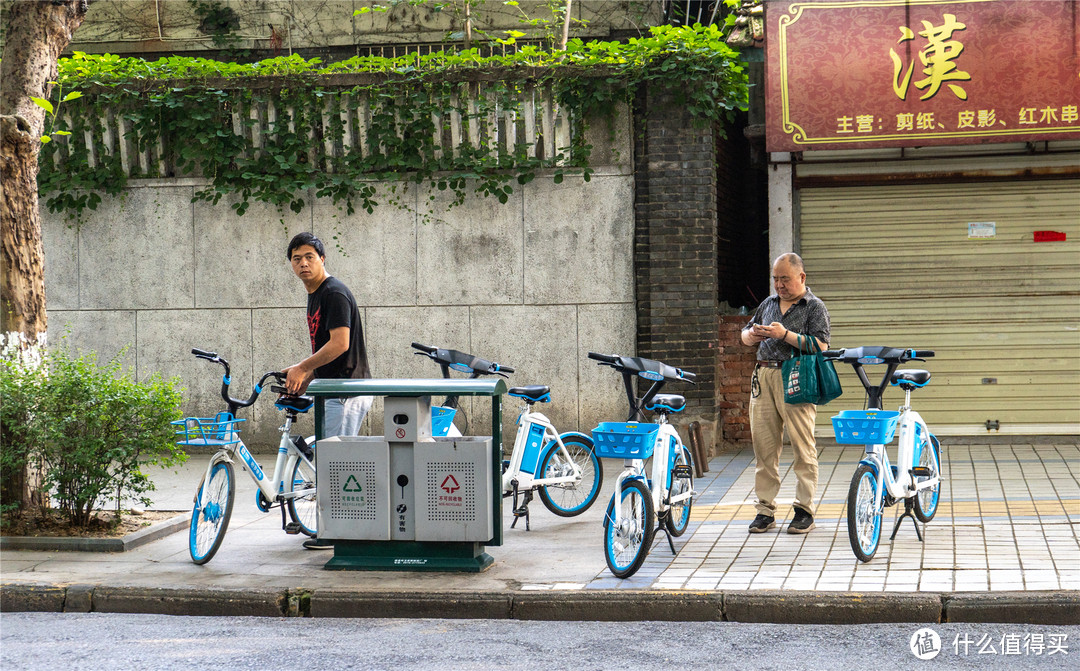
[589,352,697,578]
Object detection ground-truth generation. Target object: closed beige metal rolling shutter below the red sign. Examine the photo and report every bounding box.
[799,179,1080,435]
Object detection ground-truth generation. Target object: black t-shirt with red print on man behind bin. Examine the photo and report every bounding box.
[308,276,372,379]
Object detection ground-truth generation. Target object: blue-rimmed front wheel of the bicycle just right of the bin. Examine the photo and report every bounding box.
[604,480,656,578]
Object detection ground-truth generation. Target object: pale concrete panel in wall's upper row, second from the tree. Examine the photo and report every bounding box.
[79,187,194,310]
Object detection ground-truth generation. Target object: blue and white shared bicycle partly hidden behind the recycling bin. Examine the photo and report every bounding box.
[413,343,604,531]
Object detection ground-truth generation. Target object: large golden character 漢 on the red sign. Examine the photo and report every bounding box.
[889,14,971,100]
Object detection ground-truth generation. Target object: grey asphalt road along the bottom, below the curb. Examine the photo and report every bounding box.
[0,613,1080,671]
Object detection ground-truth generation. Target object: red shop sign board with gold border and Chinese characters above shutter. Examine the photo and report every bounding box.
[766,0,1080,151]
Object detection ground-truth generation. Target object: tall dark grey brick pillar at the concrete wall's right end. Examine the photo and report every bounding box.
[634,84,719,448]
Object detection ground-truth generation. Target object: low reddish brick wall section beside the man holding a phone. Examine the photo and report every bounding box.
[716,314,756,445]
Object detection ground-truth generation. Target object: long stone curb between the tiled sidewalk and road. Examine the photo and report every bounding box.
[0,583,1080,625]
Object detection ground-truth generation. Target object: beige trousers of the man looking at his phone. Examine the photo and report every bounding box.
[750,368,818,516]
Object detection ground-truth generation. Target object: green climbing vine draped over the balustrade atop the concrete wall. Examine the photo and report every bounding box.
[39,26,746,216]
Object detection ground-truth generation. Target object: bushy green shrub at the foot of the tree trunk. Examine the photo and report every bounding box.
[2,339,187,526]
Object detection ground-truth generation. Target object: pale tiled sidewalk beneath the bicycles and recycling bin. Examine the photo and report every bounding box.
[0,441,1080,594]
